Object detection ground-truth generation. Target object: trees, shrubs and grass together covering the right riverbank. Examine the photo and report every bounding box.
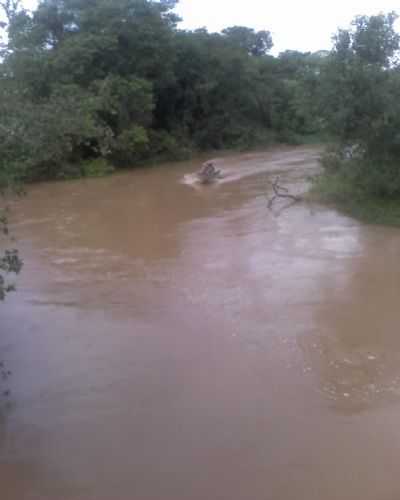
[316,13,400,215]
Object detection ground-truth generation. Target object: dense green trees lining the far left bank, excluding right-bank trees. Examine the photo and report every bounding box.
[0,0,324,181]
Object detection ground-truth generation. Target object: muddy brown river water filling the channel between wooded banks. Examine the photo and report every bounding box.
[0,148,400,500]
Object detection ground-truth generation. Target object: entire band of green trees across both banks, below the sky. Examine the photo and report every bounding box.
[0,0,400,198]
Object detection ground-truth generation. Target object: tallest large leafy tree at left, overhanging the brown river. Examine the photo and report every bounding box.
[0,0,181,181]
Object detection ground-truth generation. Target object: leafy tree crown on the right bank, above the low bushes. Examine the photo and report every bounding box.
[322,13,400,150]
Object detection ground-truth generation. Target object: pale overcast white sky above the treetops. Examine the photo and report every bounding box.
[24,0,400,54]
